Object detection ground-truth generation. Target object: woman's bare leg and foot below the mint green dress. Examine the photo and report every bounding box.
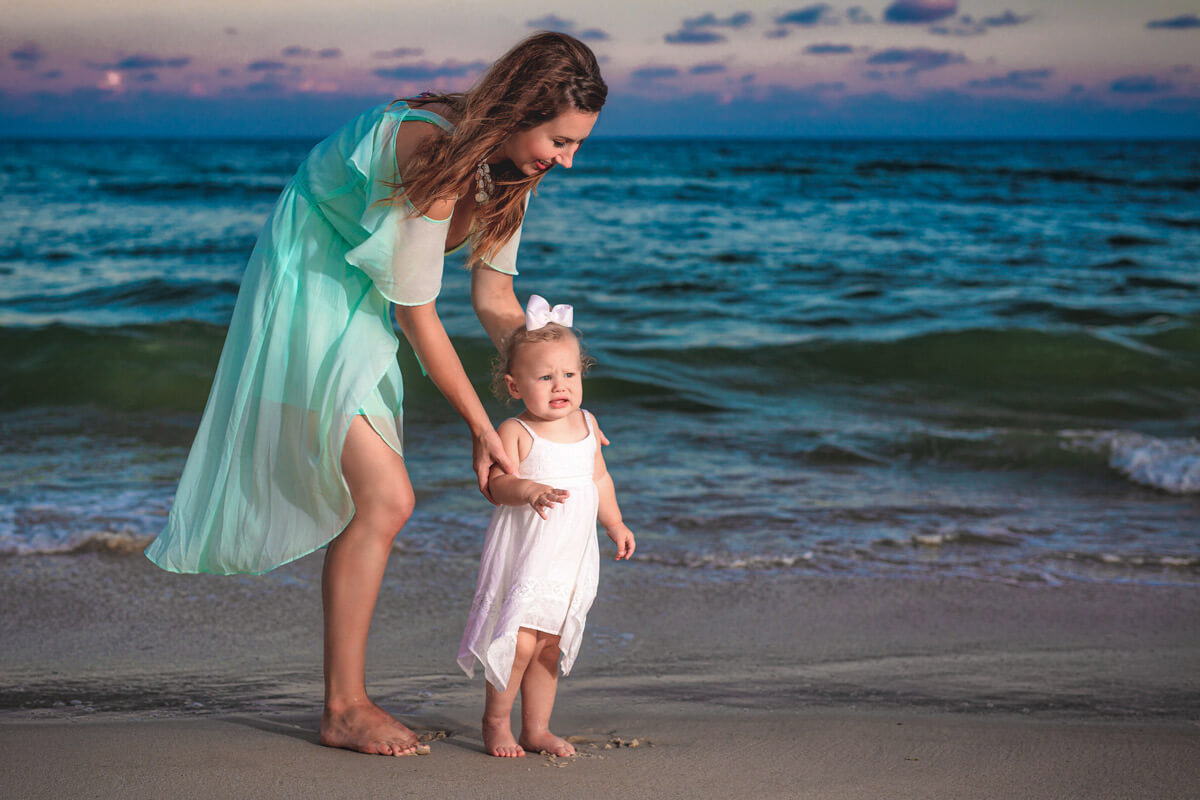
[320,416,418,756]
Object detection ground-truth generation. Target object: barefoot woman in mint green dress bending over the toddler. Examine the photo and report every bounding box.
[146,32,607,756]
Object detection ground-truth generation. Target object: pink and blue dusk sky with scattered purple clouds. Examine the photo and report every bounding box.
[0,0,1200,138]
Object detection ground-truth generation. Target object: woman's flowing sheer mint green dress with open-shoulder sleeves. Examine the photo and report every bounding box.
[146,103,521,575]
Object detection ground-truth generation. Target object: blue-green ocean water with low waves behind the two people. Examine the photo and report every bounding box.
[0,139,1200,584]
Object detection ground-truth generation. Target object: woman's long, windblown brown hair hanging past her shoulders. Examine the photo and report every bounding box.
[390,32,608,263]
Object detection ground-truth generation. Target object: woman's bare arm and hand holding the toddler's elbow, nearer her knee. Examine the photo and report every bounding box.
[395,302,517,500]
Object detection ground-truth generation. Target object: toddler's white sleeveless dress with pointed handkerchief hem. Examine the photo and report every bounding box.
[458,411,600,692]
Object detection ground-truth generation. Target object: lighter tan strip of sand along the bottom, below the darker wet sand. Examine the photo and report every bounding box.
[0,708,1200,800]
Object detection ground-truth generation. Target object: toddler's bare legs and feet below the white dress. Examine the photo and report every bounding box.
[484,627,575,758]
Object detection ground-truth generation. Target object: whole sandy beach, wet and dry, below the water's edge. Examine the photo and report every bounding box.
[0,553,1200,798]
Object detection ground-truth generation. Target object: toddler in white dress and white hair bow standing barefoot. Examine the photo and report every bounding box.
[458,295,635,757]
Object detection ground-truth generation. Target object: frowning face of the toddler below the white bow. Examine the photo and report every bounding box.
[504,338,583,420]
